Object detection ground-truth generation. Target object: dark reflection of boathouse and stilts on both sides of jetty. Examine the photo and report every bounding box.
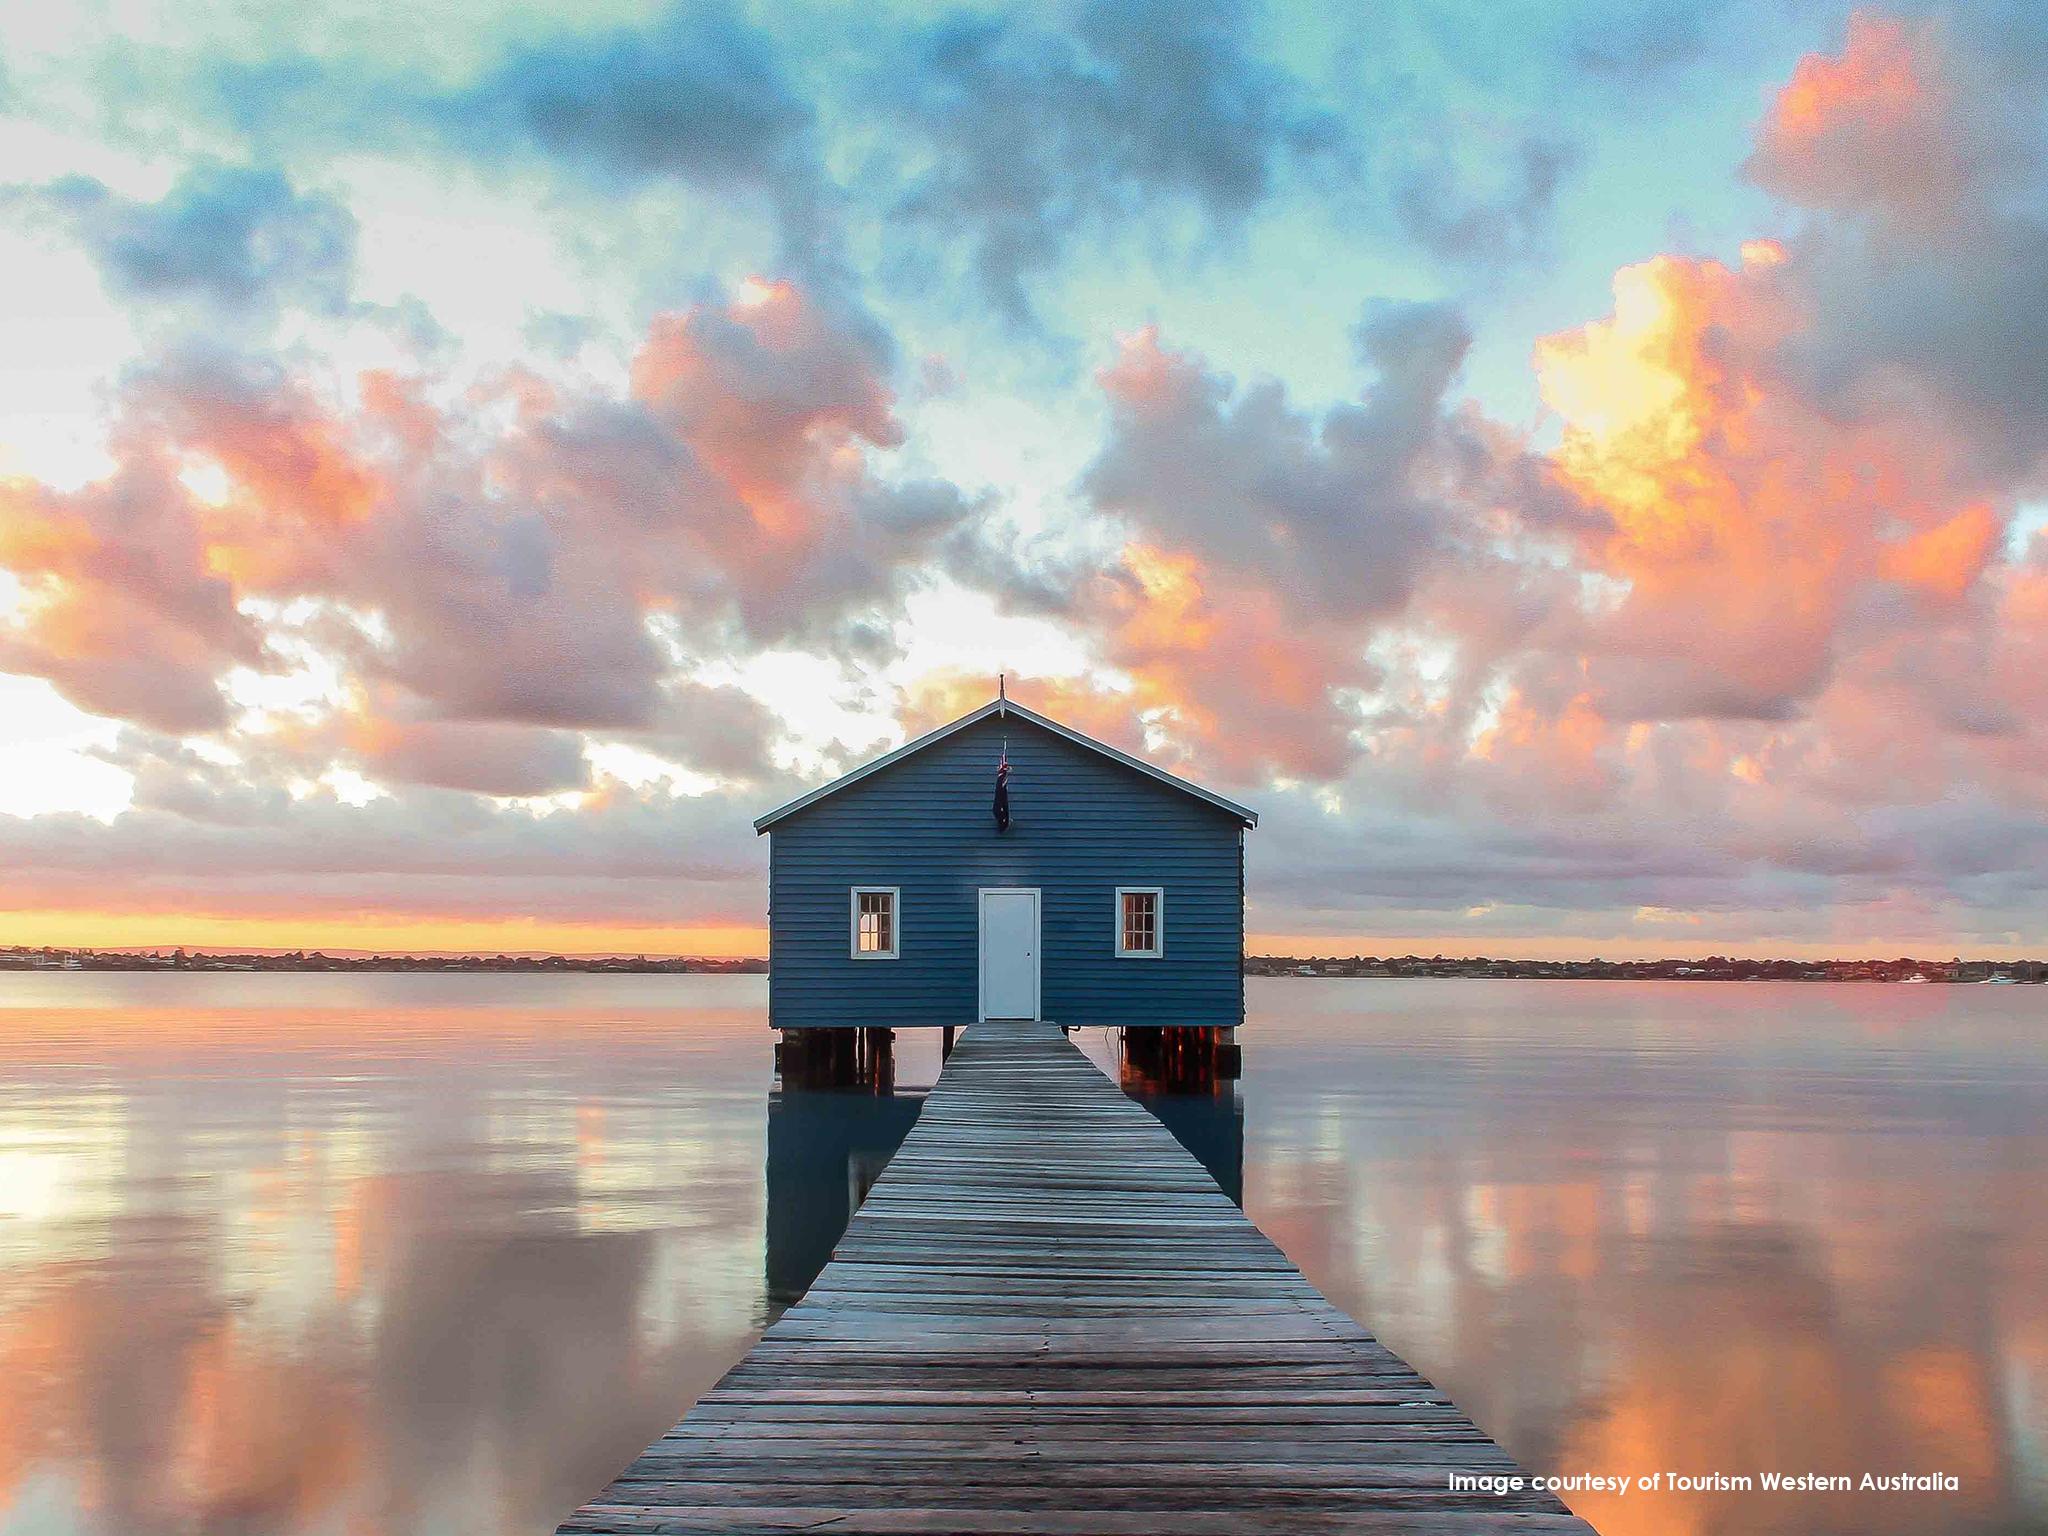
[766,1030,1245,1315]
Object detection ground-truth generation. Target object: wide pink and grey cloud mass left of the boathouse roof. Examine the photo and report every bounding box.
[0,283,985,795]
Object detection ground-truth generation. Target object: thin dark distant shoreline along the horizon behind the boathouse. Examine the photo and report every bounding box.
[0,944,2048,985]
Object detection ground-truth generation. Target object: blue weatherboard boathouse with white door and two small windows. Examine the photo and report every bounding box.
[754,698,1257,1030]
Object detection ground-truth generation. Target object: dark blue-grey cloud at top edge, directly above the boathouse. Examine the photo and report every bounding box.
[881,0,1348,324]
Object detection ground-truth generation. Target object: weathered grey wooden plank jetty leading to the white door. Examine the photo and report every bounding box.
[561,1020,1591,1536]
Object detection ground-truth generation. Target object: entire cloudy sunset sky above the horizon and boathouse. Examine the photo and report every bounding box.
[0,0,2048,956]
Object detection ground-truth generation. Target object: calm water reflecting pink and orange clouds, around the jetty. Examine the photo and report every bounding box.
[0,973,2048,1536]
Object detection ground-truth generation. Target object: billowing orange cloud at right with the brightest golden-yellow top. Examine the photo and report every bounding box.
[1536,248,2003,717]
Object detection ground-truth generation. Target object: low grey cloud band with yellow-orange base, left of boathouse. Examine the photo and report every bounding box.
[0,741,774,930]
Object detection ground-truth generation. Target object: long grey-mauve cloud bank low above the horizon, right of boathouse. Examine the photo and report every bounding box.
[1247,762,2048,952]
